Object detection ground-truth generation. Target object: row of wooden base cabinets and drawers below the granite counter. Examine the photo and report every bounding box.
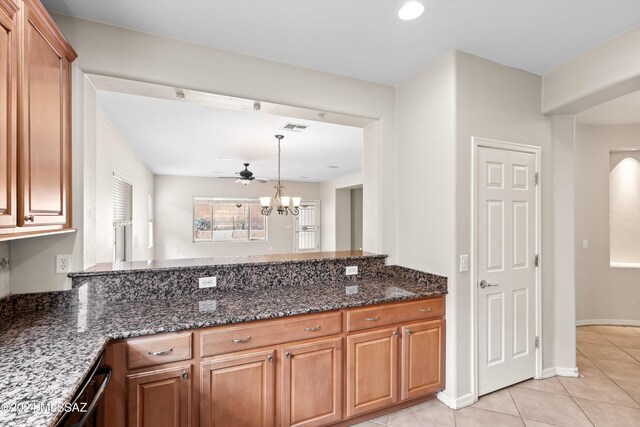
[103,297,445,427]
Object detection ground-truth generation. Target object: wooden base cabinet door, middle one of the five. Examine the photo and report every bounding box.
[281,338,342,427]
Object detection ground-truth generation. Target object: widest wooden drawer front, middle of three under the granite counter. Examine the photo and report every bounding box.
[201,313,342,357]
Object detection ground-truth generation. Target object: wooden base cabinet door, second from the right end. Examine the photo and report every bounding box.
[347,327,398,417]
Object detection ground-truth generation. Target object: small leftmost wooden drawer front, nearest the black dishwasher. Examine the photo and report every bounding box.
[127,332,192,369]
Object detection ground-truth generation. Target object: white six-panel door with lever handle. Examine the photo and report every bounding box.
[476,147,537,395]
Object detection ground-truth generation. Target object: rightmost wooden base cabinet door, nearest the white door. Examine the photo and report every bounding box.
[400,320,444,400]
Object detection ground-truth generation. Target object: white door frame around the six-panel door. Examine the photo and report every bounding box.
[469,136,544,402]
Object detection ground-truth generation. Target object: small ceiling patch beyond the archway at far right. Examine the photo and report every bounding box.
[576,91,640,126]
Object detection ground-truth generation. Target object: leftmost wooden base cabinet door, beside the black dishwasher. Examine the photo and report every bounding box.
[127,365,193,427]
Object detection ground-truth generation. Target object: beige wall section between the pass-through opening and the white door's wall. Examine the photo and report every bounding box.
[396,51,460,400]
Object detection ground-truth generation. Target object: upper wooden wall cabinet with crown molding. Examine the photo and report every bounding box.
[0,0,77,240]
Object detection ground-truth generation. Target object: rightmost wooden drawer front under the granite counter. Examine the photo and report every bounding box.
[347,297,444,332]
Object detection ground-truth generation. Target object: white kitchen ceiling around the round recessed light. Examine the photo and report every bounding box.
[43,0,640,85]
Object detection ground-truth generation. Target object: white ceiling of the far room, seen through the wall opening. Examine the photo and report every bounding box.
[97,90,363,181]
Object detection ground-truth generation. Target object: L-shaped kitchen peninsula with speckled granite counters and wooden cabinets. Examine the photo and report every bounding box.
[0,252,447,426]
